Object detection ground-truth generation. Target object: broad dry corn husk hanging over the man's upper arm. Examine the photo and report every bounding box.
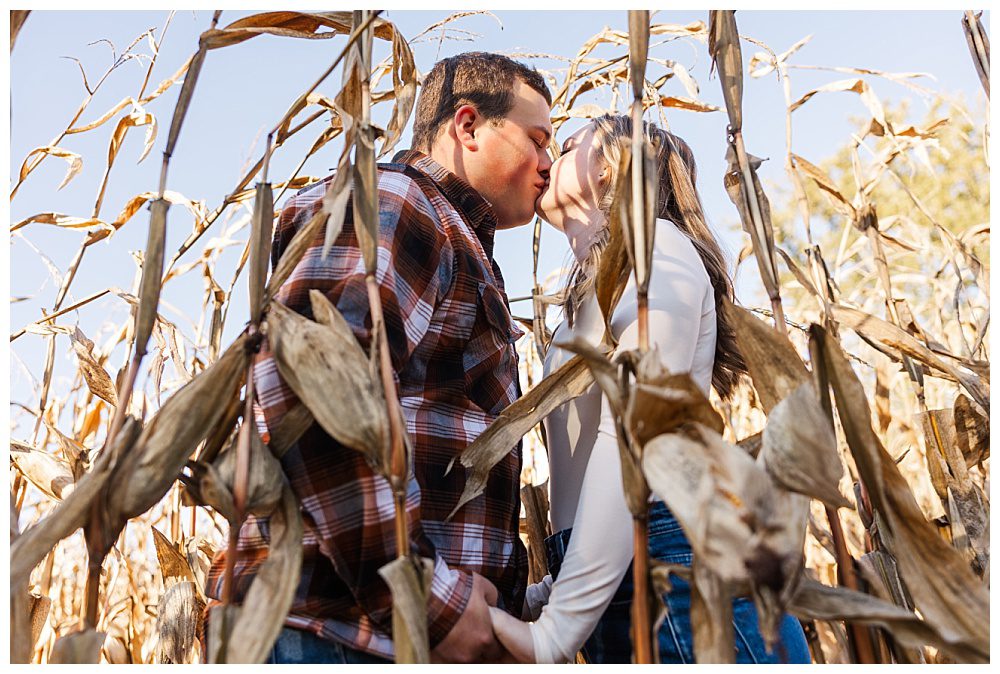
[267,290,389,466]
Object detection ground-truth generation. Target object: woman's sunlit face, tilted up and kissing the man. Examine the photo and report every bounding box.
[536,124,609,231]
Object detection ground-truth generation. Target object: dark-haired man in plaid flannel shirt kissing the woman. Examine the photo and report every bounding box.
[208,53,552,663]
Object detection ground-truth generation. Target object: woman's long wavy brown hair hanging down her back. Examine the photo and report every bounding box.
[565,115,747,400]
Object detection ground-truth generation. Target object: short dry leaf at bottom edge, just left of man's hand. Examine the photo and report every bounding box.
[378,557,434,665]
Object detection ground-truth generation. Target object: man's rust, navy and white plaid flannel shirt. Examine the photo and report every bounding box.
[207,151,527,658]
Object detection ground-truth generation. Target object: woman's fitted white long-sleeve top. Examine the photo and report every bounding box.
[528,219,716,663]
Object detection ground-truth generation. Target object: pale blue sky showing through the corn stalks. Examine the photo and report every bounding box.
[8,10,989,434]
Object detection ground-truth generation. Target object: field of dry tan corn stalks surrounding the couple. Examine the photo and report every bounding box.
[10,10,990,663]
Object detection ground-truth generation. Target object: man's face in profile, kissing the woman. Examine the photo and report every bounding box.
[462,78,552,229]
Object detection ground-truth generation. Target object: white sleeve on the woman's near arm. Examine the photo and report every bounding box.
[531,231,711,663]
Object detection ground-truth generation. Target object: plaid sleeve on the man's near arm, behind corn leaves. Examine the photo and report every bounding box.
[254,180,472,647]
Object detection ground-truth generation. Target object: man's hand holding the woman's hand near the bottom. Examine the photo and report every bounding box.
[431,573,503,663]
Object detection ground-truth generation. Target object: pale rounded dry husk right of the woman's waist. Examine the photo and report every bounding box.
[760,382,851,508]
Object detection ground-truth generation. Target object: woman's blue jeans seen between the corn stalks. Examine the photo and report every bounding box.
[545,501,812,664]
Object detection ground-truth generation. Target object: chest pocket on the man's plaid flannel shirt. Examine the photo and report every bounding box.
[463,281,524,415]
